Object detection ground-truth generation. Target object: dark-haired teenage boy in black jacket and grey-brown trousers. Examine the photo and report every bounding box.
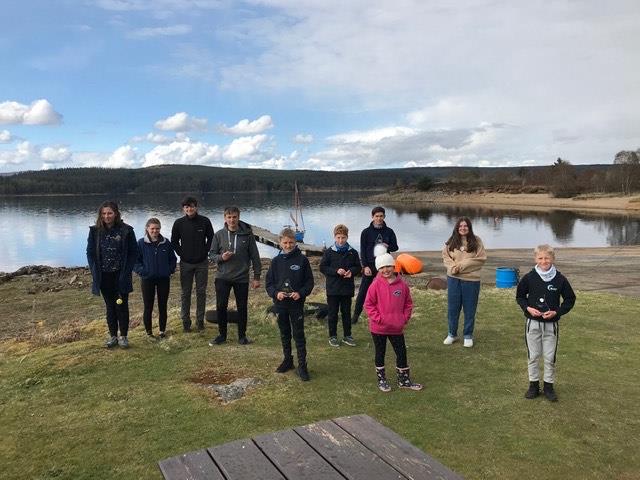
[171,196,213,333]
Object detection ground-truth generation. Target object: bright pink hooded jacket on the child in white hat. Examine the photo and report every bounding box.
[364,274,413,335]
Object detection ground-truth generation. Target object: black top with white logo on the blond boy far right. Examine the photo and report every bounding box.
[516,269,576,322]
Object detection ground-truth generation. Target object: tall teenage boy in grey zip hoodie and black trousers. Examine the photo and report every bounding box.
[209,206,262,346]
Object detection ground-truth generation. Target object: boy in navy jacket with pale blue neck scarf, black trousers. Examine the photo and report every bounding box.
[320,224,362,347]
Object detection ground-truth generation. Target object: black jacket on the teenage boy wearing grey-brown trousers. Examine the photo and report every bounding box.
[171,213,213,263]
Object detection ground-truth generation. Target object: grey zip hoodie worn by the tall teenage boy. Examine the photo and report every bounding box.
[209,221,262,283]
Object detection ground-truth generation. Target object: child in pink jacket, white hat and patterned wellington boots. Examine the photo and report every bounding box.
[364,253,422,392]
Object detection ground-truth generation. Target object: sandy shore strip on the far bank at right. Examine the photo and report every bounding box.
[370,191,640,215]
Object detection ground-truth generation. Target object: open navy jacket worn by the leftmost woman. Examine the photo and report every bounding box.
[87,222,138,295]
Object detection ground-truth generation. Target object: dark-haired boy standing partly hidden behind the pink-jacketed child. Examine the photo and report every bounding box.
[352,206,398,323]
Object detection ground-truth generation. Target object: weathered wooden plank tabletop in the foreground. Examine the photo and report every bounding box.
[158,415,462,480]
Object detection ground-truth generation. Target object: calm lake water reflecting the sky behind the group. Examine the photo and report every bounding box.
[0,194,640,272]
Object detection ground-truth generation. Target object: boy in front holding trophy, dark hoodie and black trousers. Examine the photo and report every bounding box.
[265,228,313,382]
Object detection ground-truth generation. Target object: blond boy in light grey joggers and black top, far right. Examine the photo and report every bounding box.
[516,245,576,402]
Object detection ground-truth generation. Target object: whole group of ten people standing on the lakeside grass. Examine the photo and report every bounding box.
[87,196,575,401]
